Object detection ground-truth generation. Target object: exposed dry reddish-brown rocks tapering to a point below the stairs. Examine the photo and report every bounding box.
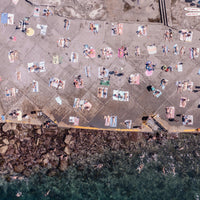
[0,123,170,176]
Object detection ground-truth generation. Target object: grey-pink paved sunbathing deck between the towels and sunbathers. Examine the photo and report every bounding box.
[0,2,200,130]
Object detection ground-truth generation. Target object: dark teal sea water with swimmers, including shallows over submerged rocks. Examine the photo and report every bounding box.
[0,135,200,200]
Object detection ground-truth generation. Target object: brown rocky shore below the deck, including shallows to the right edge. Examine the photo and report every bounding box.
[0,123,200,181]
